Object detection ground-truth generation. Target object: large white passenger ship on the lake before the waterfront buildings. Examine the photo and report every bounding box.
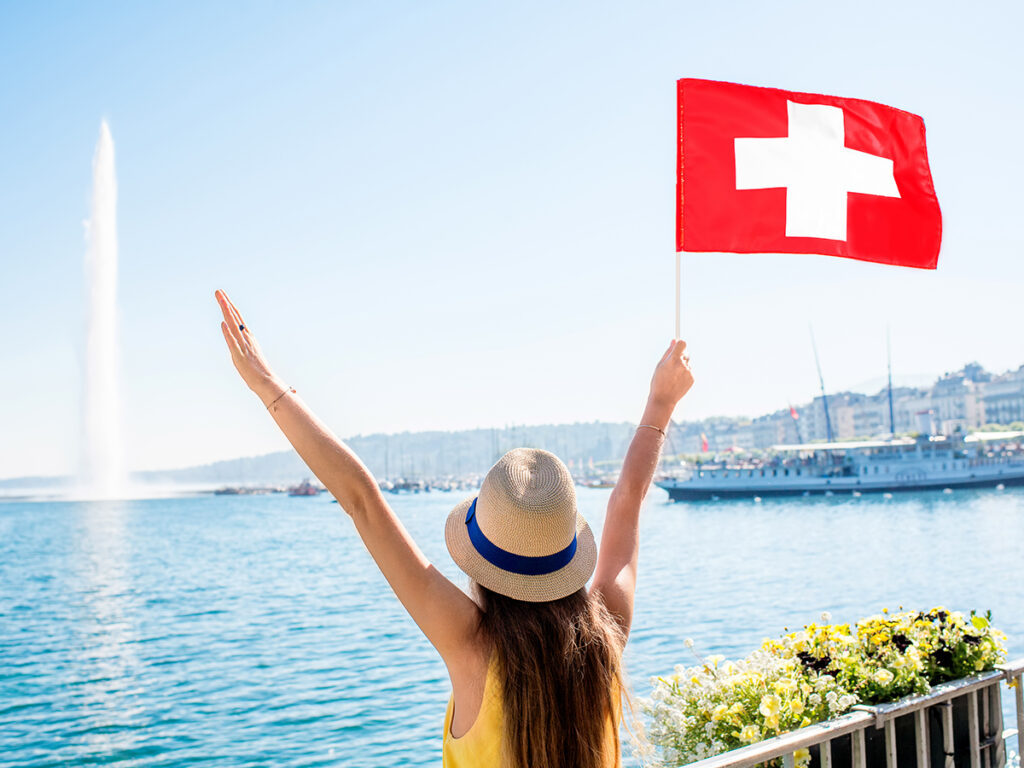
[655,432,1024,501]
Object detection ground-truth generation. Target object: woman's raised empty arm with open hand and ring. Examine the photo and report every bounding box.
[215,291,478,666]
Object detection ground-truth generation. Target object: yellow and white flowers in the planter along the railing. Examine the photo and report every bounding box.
[642,607,1006,766]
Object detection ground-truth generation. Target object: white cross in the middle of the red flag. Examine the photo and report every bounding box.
[735,101,900,240]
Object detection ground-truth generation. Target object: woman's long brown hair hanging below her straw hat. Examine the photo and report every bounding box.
[473,582,628,768]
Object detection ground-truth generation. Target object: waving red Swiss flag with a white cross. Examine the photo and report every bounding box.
[676,79,942,269]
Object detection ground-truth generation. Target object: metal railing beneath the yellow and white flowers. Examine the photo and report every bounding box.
[687,658,1024,768]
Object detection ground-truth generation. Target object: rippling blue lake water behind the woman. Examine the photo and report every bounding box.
[0,488,1024,767]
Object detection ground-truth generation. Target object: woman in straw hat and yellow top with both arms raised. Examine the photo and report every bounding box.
[215,291,693,768]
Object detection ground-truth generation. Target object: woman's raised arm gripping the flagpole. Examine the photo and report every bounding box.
[591,340,693,633]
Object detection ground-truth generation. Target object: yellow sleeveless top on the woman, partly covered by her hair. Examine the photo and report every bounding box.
[441,656,623,768]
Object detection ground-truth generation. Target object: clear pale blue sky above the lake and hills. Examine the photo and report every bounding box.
[0,2,1024,477]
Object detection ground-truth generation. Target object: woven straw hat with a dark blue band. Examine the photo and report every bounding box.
[444,449,597,602]
